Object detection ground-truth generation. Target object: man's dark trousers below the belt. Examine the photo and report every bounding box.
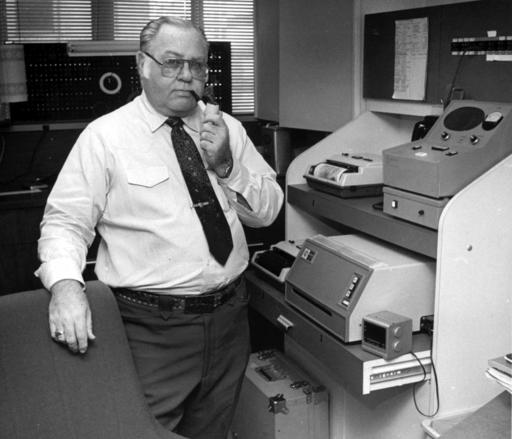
[118,281,250,439]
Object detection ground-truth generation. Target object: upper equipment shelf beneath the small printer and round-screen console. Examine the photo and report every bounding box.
[288,184,437,259]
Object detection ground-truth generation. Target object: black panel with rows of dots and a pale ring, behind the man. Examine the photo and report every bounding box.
[10,41,232,123]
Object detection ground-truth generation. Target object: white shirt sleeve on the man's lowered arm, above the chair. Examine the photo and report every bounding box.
[35,128,108,289]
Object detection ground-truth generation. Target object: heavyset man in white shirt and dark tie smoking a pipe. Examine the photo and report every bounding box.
[36,17,283,439]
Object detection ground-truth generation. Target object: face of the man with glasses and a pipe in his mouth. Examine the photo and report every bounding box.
[137,24,208,117]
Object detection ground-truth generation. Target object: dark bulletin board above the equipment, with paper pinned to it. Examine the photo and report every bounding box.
[363,0,512,104]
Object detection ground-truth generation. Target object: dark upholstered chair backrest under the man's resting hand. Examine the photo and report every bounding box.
[0,281,187,439]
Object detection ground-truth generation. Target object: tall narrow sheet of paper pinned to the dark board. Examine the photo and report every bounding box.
[393,17,428,101]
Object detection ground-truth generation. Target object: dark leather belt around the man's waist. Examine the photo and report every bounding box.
[111,277,241,314]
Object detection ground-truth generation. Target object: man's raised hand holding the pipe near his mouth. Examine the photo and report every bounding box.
[199,104,233,178]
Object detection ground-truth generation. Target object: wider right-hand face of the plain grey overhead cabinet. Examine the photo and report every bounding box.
[279,0,353,131]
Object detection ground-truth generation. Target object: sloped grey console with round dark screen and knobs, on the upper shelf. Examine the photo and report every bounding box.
[383,100,512,198]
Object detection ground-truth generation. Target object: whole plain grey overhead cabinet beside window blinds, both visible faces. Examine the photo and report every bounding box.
[255,0,353,132]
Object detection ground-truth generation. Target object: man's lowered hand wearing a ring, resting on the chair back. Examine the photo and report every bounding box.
[49,279,96,354]
